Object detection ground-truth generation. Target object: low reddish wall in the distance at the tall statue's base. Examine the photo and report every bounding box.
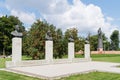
[75,51,120,54]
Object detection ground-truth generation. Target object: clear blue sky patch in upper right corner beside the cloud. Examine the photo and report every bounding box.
[82,0,120,25]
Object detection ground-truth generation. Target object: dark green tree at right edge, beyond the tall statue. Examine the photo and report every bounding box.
[110,30,119,50]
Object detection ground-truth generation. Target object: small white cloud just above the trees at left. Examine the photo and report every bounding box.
[11,10,36,25]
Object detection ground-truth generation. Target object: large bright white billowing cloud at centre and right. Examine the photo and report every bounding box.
[43,0,118,37]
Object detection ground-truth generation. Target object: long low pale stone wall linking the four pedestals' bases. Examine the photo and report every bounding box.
[6,58,91,68]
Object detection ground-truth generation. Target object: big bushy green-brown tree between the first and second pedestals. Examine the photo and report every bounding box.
[23,20,57,59]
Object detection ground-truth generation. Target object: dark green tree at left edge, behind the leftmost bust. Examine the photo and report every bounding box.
[0,16,24,55]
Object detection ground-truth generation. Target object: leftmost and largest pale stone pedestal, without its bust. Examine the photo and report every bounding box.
[12,37,22,62]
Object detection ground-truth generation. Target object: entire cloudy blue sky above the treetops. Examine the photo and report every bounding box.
[0,0,120,36]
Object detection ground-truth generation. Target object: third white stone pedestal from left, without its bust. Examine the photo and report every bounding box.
[68,42,74,60]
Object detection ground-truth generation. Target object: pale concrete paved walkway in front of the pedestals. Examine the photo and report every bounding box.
[4,61,120,79]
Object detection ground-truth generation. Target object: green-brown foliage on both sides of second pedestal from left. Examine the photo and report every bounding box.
[23,20,65,59]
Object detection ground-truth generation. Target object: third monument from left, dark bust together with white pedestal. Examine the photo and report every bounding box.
[68,35,74,61]
